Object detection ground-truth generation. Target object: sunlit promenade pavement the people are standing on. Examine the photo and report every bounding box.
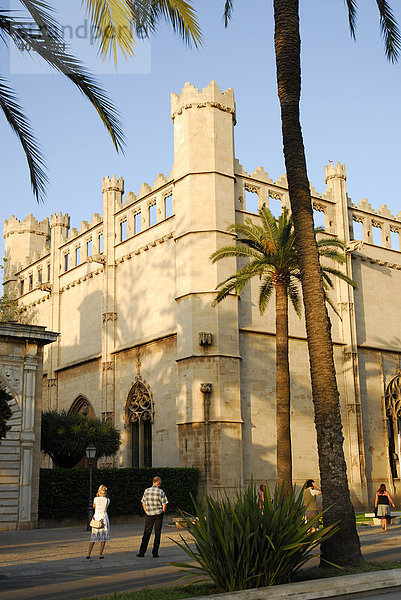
[0,523,401,600]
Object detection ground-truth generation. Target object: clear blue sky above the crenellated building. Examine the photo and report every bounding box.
[0,0,401,248]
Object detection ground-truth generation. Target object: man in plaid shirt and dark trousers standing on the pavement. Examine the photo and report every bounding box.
[137,477,168,558]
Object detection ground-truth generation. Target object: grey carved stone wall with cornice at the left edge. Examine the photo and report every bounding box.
[0,323,57,530]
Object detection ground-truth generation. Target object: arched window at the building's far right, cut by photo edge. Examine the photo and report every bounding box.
[386,375,401,479]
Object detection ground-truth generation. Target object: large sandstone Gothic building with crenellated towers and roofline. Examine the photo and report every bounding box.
[4,82,401,506]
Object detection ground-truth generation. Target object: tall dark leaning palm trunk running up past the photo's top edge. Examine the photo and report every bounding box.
[274,0,362,565]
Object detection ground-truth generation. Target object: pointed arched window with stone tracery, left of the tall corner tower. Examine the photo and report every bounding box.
[126,381,153,467]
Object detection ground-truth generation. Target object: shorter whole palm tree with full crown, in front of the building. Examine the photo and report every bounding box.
[210,207,355,495]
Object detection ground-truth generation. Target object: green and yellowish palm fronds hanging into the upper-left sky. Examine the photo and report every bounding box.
[0,0,201,201]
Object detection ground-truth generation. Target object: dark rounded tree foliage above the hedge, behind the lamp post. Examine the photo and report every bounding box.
[41,410,120,469]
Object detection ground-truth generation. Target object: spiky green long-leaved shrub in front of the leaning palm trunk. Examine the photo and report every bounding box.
[171,483,337,592]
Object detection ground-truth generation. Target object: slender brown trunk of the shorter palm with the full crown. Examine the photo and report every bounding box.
[275,277,292,495]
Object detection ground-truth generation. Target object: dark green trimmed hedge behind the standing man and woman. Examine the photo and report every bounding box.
[39,467,199,519]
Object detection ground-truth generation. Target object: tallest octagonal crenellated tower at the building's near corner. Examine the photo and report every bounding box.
[171,81,243,493]
